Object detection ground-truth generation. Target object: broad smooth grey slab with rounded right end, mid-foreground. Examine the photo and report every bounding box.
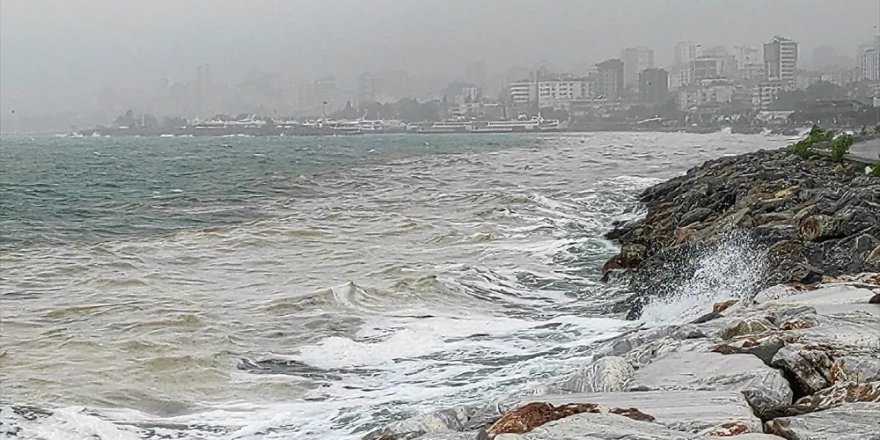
[630,352,793,410]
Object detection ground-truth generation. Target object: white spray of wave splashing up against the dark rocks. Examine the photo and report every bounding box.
[641,230,767,324]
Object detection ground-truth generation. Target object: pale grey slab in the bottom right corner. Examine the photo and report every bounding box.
[767,402,880,440]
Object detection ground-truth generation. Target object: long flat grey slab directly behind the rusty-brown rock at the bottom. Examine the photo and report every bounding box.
[490,390,761,433]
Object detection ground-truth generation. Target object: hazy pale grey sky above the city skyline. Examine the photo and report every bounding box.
[0,0,880,114]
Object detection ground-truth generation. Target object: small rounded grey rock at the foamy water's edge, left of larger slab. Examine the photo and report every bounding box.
[536,356,635,394]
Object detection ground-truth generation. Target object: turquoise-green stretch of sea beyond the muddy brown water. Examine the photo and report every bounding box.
[0,135,534,247]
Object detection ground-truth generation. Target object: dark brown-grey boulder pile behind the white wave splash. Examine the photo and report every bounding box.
[603,150,880,318]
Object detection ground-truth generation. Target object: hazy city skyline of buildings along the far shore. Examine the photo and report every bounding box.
[87,31,880,131]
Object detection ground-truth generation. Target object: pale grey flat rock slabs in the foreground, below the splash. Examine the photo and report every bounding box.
[364,274,880,440]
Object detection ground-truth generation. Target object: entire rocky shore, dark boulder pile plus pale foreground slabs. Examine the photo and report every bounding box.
[363,143,880,440]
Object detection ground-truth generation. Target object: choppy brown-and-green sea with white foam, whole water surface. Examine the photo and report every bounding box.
[0,132,786,439]
